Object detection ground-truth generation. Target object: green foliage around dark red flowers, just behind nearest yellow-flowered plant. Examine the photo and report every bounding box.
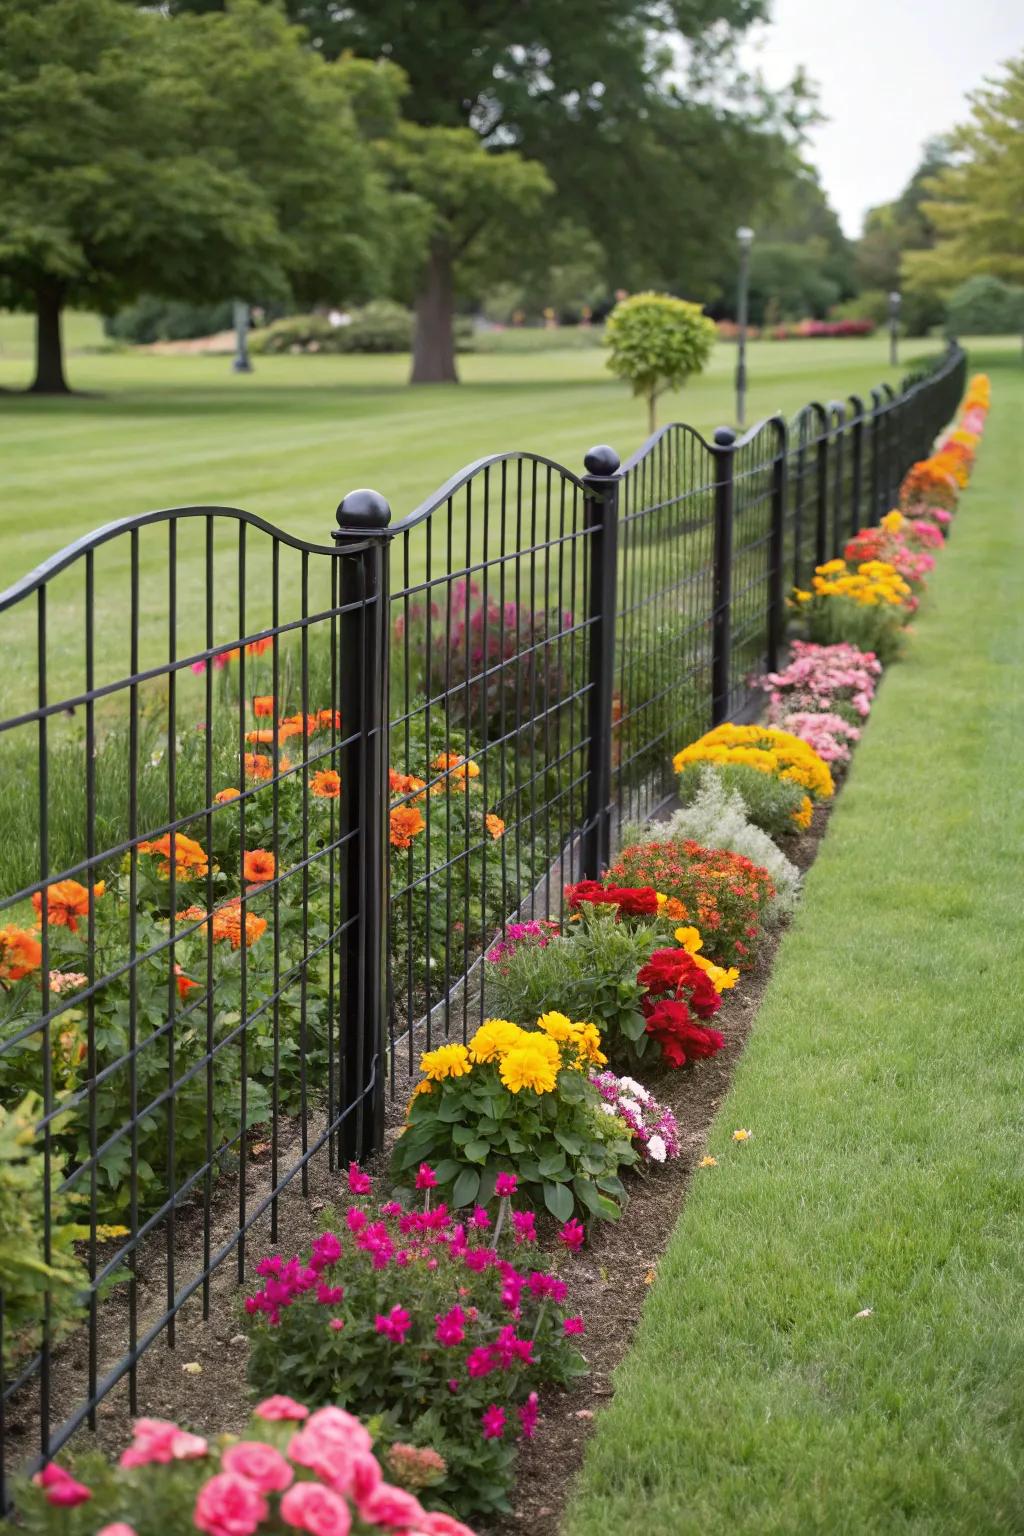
[488,905,657,1066]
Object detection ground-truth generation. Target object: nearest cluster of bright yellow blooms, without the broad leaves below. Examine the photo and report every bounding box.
[413,1014,608,1097]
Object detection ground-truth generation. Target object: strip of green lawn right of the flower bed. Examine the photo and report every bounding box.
[565,356,1024,1536]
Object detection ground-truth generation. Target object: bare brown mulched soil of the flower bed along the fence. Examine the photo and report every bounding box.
[6,802,834,1536]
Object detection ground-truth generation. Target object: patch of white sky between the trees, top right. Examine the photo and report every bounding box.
[743,0,1024,237]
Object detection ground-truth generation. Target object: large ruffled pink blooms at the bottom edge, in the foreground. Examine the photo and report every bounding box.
[34,1396,475,1536]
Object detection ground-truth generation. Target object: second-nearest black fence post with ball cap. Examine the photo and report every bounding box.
[580,442,622,880]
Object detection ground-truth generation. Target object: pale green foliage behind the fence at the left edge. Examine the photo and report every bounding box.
[0,1092,89,1373]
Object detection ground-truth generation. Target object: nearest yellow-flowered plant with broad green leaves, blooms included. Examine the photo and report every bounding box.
[391,1009,636,1221]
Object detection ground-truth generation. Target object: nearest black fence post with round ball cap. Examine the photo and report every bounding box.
[333,490,391,1161]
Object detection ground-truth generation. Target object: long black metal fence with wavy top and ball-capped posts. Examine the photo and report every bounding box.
[0,347,966,1493]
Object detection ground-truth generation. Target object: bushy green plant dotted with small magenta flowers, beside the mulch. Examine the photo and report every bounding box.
[249,1200,586,1514]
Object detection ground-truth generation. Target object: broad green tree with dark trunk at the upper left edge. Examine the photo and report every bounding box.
[0,0,398,392]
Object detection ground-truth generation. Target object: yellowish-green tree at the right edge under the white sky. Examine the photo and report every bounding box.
[904,54,1024,292]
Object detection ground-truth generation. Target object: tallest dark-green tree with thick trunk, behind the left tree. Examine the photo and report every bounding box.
[170,0,804,378]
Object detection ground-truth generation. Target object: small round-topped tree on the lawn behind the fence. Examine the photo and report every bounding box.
[605,293,715,432]
